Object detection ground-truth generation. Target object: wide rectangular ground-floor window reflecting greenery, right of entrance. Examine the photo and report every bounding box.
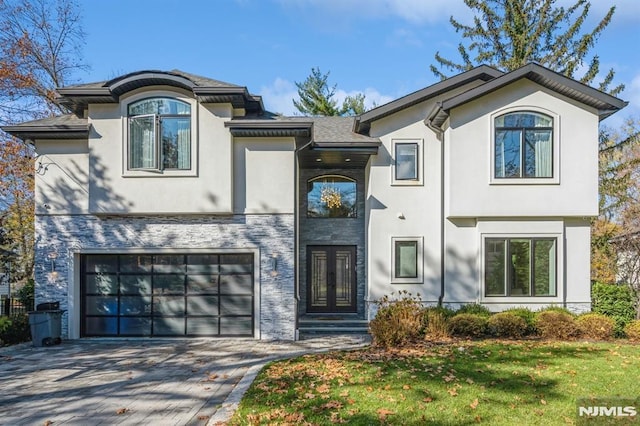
[484,238,557,297]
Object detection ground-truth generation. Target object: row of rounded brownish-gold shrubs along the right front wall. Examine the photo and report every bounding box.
[369,292,640,347]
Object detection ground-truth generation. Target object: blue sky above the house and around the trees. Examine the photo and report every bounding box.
[77,0,640,125]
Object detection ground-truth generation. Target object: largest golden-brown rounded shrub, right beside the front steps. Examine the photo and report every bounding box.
[369,291,424,348]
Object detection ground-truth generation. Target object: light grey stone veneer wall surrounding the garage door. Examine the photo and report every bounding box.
[35,214,296,340]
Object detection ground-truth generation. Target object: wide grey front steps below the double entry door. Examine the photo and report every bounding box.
[298,315,369,340]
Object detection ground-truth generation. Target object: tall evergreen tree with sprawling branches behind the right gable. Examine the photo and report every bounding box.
[430,0,624,95]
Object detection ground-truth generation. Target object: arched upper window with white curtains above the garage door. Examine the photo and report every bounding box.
[127,98,191,170]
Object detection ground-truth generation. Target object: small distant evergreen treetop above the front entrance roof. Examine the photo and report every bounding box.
[293,68,365,117]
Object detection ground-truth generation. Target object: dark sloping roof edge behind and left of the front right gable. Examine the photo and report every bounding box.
[354,65,504,133]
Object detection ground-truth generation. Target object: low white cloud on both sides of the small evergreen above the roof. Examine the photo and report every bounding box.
[259,77,394,115]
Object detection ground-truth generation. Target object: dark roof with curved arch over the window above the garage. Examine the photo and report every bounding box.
[56,70,264,116]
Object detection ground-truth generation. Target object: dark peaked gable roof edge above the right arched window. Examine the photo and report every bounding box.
[427,63,628,128]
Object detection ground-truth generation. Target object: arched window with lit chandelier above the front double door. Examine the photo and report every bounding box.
[307,175,358,217]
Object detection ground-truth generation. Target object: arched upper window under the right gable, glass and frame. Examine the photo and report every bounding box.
[494,112,553,178]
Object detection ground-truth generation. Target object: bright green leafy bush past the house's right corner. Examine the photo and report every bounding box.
[591,283,636,337]
